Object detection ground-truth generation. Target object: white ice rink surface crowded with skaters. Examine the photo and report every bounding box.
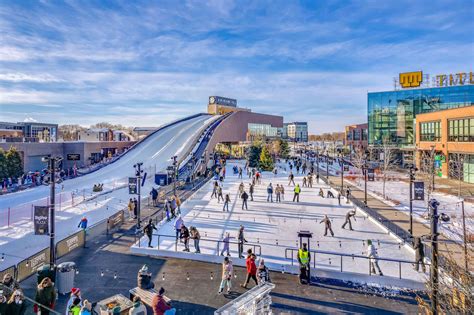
[136,161,425,281]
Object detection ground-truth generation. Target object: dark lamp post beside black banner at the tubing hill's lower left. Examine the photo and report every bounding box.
[41,155,63,270]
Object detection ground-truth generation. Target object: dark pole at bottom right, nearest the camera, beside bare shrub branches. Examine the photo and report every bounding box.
[428,199,439,315]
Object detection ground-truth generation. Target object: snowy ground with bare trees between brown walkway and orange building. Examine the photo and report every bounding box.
[319,159,474,241]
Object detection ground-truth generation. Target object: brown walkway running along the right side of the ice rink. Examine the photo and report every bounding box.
[322,172,474,271]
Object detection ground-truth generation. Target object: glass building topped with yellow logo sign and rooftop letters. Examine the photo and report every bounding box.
[367,71,474,164]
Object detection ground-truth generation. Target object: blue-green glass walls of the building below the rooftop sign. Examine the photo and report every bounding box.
[368,85,474,148]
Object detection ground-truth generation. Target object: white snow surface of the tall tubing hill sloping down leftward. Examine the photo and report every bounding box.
[0,116,216,270]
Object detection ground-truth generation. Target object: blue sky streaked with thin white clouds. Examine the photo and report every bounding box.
[0,0,474,133]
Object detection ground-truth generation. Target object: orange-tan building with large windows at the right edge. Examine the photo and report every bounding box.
[415,106,474,183]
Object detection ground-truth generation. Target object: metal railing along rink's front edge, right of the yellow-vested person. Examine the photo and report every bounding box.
[285,248,430,279]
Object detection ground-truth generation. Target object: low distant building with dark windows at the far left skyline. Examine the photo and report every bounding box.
[0,122,58,142]
